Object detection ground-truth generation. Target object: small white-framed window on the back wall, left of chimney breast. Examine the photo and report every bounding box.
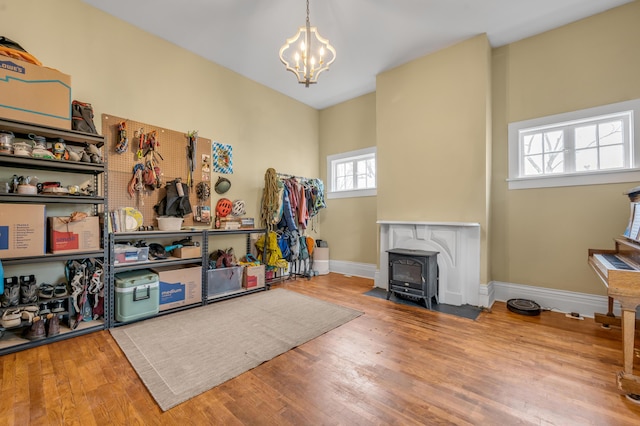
[327,147,376,198]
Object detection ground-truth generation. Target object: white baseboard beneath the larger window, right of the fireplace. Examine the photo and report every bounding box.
[488,281,620,318]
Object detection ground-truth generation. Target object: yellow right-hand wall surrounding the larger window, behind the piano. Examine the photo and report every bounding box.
[490,2,640,294]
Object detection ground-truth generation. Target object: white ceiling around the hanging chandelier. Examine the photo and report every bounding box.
[83,0,633,109]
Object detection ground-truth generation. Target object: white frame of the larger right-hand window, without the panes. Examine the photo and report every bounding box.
[507,99,640,189]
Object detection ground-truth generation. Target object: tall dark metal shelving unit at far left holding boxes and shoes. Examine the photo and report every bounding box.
[0,118,111,355]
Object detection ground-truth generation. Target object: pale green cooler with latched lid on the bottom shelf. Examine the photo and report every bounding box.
[115,269,160,322]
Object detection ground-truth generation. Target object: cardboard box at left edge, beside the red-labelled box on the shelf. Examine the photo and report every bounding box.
[0,204,47,259]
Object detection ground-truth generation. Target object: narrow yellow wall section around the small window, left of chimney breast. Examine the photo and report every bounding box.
[320,93,378,264]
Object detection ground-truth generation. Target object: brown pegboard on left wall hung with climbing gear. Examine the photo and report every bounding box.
[102,114,211,226]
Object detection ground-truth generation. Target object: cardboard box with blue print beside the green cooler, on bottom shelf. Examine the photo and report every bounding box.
[152,265,202,311]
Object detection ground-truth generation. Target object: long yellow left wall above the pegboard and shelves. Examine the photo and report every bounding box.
[0,0,319,226]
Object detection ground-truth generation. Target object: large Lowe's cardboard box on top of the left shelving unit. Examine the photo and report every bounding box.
[0,56,72,130]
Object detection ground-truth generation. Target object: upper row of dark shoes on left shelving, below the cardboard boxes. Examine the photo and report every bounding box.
[0,275,69,308]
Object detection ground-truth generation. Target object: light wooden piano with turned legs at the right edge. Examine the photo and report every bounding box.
[588,237,640,395]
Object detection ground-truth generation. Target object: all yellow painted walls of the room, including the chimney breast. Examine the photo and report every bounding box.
[6,0,640,294]
